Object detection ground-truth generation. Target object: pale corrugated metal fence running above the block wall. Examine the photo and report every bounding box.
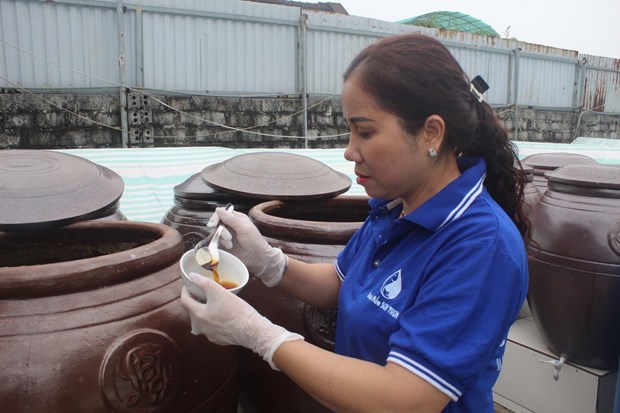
[0,0,620,114]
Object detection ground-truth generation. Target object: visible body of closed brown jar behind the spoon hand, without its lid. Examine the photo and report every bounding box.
[161,173,263,251]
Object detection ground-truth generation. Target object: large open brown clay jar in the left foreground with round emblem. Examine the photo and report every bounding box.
[0,221,238,413]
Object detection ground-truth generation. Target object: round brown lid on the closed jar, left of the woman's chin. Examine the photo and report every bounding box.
[201,152,351,200]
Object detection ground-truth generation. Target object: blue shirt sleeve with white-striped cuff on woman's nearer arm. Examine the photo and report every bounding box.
[388,222,527,400]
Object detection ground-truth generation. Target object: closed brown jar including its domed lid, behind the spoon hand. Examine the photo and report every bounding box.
[161,151,351,251]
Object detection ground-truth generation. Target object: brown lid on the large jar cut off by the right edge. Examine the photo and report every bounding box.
[545,164,620,189]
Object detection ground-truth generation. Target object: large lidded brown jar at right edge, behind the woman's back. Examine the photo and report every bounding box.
[528,164,620,370]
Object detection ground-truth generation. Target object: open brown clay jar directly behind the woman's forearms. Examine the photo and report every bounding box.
[239,195,370,413]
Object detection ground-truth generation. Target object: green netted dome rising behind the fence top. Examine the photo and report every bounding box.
[399,11,499,37]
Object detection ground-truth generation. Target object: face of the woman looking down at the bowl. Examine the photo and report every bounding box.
[342,73,439,212]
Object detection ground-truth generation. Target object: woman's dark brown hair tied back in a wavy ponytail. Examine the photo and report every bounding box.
[344,34,529,236]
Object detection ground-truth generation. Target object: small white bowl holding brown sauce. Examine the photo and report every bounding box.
[180,249,250,303]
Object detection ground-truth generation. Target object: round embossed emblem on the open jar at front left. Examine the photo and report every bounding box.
[99,329,183,413]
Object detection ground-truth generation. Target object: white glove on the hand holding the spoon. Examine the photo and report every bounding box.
[207,207,288,287]
